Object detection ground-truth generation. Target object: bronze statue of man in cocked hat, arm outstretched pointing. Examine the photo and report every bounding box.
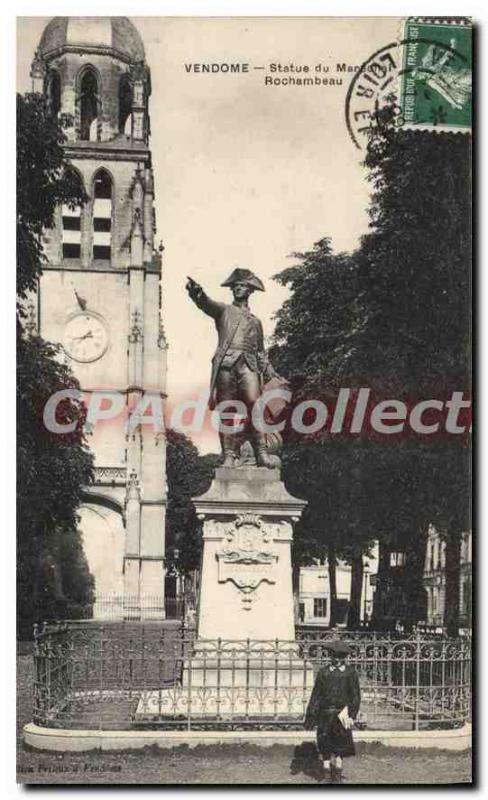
[186,267,286,468]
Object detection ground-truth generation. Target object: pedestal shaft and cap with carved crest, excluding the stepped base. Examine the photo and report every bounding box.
[193,467,306,649]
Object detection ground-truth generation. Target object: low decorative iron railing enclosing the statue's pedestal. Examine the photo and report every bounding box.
[34,621,471,730]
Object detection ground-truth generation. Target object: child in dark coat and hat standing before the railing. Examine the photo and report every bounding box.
[305,640,361,783]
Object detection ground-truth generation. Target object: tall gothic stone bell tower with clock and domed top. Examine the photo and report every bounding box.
[31,17,166,617]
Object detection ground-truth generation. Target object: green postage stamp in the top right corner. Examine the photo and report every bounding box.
[400,18,472,131]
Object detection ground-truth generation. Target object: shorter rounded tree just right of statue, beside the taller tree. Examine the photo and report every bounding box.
[272,244,375,627]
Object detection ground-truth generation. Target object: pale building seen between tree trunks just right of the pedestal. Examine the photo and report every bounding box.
[298,543,378,627]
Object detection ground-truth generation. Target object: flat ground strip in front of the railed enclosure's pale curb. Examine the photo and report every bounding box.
[17,655,471,785]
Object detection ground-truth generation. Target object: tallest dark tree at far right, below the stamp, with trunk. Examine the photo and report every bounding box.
[358,125,471,634]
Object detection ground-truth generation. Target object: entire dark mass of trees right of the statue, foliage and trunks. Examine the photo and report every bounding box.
[273,125,471,632]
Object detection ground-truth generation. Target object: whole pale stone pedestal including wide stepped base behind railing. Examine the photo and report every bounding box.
[136,467,314,722]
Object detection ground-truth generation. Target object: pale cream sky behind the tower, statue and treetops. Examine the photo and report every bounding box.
[17,17,400,452]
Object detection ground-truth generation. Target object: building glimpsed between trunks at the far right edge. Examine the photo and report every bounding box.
[424,525,472,629]
